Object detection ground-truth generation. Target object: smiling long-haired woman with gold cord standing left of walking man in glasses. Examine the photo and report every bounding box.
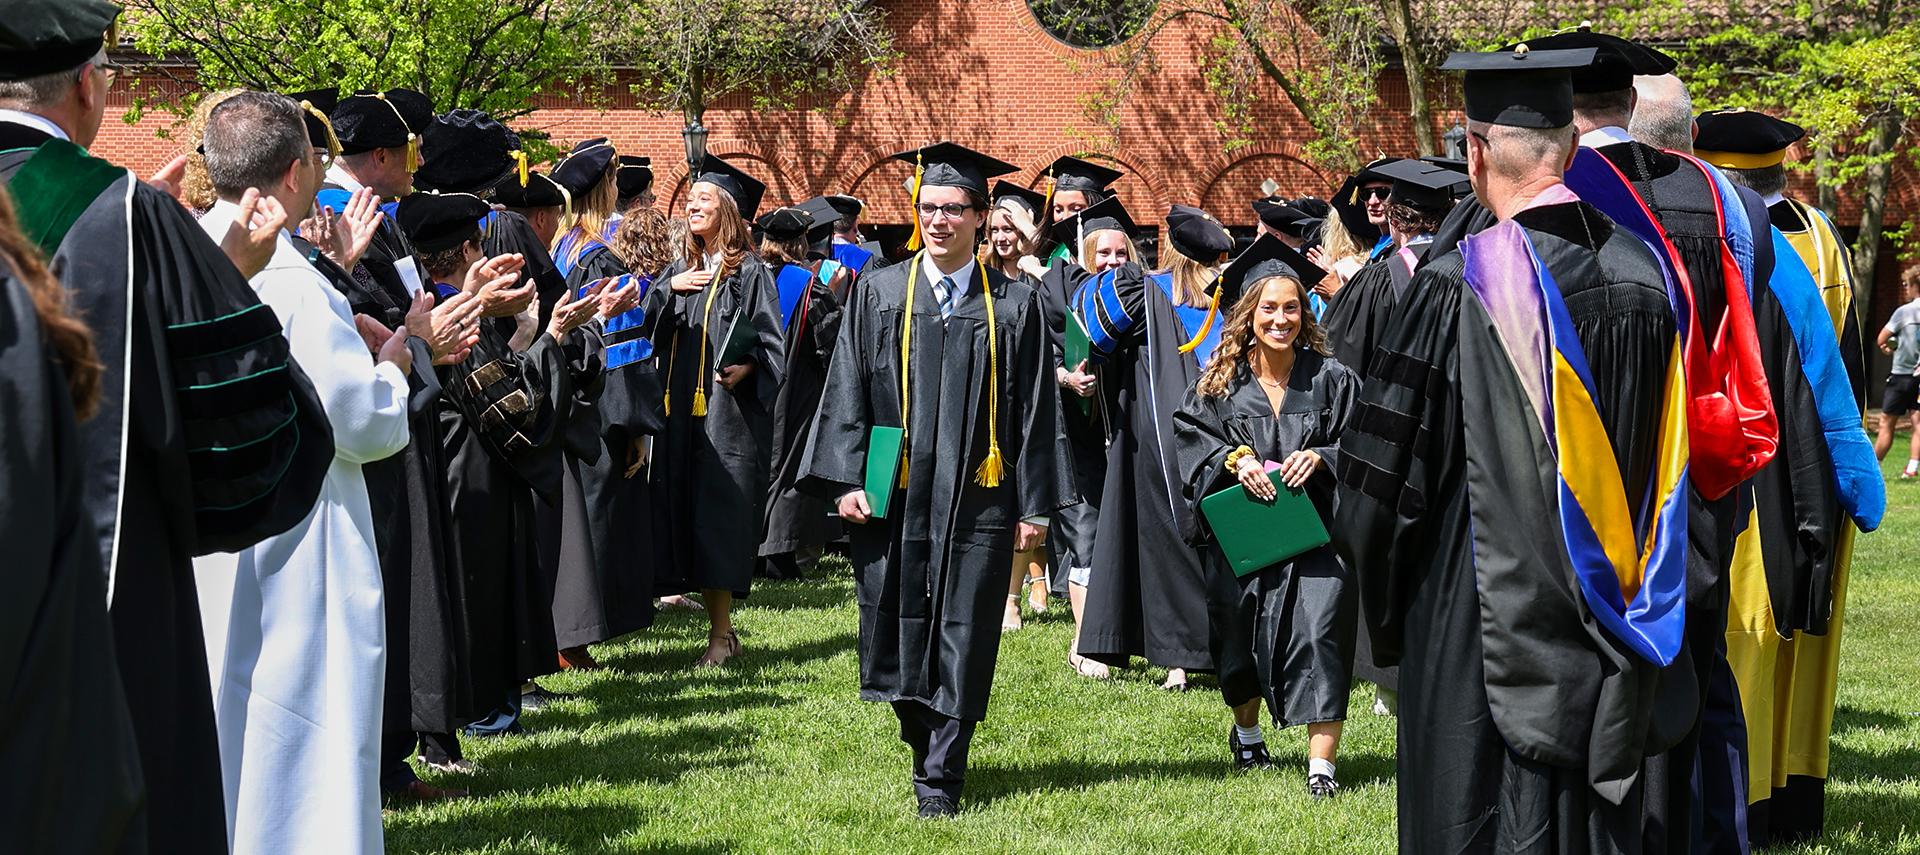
[653,156,785,667]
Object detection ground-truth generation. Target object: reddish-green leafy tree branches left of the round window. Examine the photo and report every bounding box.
[618,0,893,141]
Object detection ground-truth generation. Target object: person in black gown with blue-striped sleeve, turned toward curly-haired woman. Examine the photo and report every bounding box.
[1073,202,1233,690]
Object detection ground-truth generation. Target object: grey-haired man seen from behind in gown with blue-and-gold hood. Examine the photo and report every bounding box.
[1332,50,1688,853]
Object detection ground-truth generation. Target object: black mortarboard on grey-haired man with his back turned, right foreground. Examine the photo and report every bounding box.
[1440,44,1596,129]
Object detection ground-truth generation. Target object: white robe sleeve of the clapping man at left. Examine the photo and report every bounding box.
[253,269,407,463]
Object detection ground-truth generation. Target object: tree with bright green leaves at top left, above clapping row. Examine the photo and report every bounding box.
[125,0,618,119]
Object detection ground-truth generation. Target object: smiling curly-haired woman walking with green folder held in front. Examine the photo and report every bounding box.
[1173,236,1359,799]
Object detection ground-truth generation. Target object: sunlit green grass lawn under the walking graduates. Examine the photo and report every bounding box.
[386,457,1920,853]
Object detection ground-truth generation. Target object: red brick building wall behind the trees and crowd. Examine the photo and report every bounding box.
[96,0,1920,313]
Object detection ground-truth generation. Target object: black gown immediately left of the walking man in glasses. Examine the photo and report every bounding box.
[760,263,843,571]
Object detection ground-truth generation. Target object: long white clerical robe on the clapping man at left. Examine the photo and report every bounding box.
[194,202,407,855]
